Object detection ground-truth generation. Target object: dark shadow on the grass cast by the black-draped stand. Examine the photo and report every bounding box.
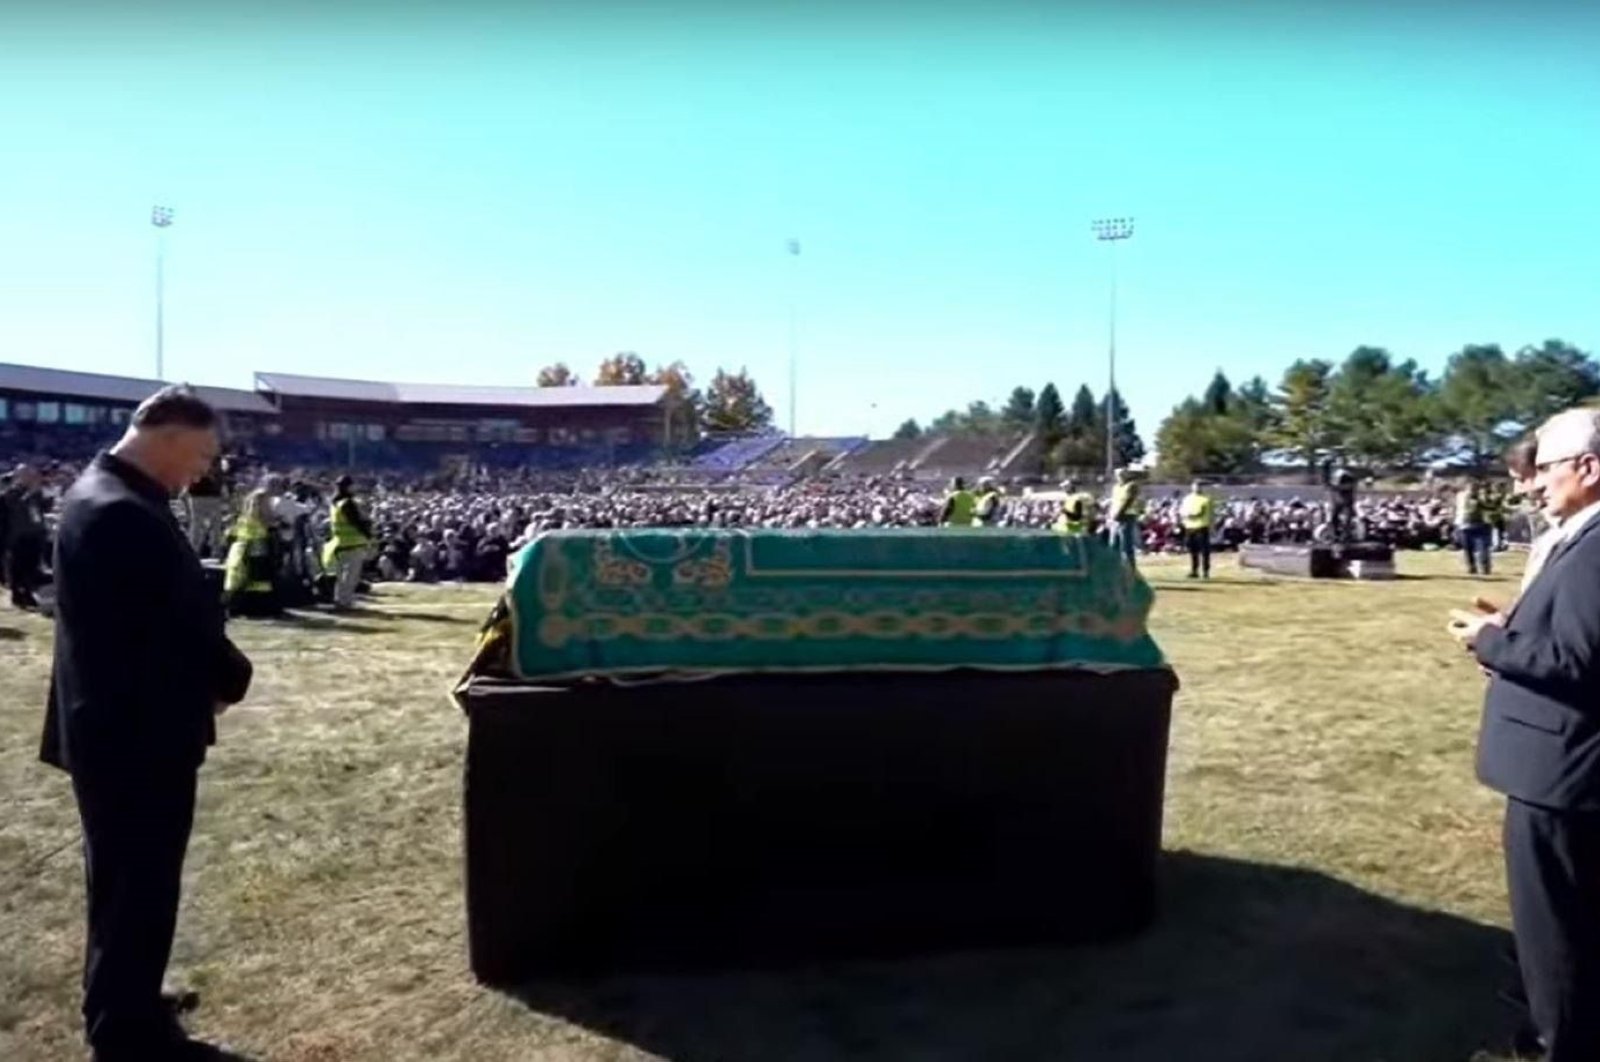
[512,852,1515,1062]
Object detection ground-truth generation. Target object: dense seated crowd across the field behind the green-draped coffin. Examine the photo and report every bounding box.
[0,459,1515,611]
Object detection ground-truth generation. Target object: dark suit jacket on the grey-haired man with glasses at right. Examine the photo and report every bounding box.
[1474,520,1600,811]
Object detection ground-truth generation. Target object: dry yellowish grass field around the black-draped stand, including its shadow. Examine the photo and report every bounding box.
[0,555,1536,1062]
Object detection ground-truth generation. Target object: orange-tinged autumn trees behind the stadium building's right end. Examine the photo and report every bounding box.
[536,350,773,446]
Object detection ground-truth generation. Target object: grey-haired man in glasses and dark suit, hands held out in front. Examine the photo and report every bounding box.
[1451,409,1600,1062]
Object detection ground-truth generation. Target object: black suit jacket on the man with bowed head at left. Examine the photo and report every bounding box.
[40,454,251,779]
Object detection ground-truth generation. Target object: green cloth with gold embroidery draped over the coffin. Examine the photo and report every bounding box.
[483,528,1165,680]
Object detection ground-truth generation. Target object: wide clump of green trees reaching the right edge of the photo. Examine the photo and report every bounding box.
[1155,339,1600,477]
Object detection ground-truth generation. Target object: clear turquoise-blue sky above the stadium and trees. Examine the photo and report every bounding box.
[0,0,1600,438]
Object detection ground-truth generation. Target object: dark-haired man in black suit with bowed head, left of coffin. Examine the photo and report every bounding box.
[40,387,251,1062]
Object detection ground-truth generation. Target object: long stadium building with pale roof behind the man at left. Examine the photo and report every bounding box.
[0,363,670,469]
